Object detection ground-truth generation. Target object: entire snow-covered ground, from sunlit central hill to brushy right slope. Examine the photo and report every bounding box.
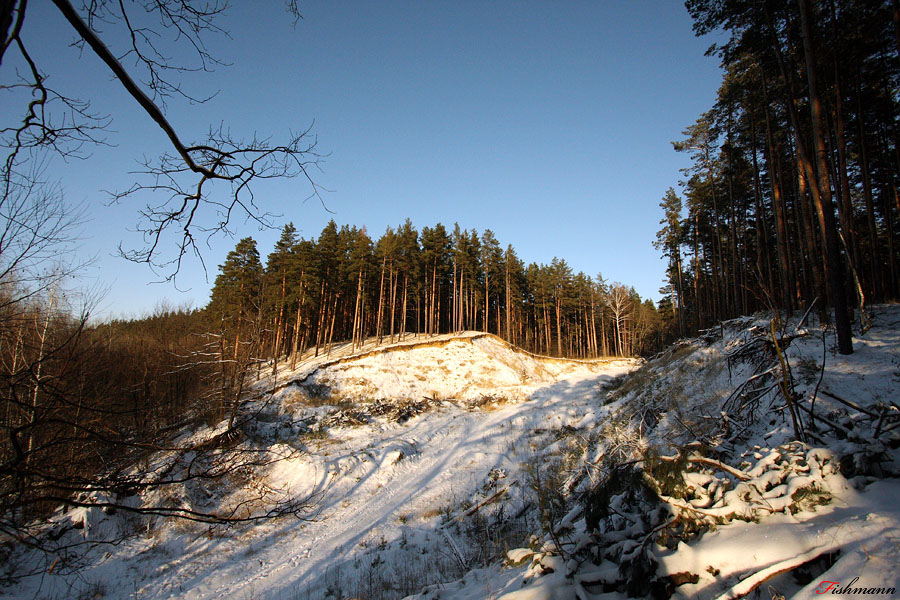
[0,306,900,600]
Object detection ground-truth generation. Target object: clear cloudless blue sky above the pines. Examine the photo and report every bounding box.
[15,0,720,316]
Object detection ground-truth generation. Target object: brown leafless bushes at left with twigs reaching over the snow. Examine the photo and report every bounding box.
[0,290,314,576]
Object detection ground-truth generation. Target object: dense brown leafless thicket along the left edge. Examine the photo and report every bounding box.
[0,280,214,540]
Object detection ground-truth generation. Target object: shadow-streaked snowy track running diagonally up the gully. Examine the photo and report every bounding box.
[156,364,632,600]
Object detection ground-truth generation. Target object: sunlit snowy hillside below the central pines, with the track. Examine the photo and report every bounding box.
[5,333,639,599]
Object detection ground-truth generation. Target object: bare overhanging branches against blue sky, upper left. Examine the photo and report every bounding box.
[0,0,320,279]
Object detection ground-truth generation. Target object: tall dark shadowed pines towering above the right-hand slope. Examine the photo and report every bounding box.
[657,0,900,353]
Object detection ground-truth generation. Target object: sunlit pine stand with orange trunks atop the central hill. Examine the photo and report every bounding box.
[206,220,662,376]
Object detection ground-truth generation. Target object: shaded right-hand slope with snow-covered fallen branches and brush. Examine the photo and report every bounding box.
[418,306,900,600]
